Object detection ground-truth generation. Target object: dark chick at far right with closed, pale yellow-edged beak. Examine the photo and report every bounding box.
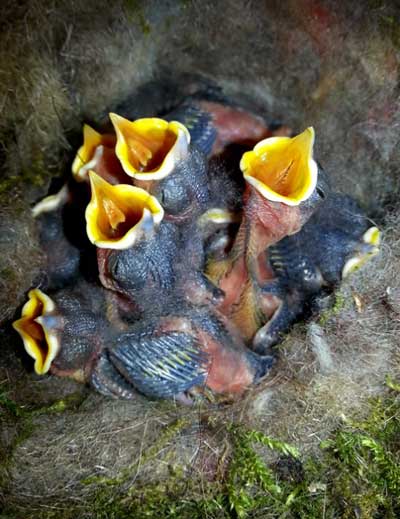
[253,193,380,354]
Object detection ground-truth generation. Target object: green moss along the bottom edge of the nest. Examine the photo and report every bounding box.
[1,378,400,519]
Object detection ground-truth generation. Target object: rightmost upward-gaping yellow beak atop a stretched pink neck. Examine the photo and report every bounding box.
[240,126,318,206]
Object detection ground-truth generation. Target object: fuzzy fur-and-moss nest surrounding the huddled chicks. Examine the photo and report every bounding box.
[0,0,400,518]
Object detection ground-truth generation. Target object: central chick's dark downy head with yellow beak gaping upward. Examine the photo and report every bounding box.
[86,172,220,311]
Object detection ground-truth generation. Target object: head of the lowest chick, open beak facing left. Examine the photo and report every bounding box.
[13,283,110,382]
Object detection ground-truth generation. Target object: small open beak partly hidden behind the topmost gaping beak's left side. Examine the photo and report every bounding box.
[72,124,117,182]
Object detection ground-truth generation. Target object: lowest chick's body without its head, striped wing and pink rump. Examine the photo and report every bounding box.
[91,304,273,403]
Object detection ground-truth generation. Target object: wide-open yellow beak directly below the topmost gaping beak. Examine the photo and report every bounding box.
[85,171,164,250]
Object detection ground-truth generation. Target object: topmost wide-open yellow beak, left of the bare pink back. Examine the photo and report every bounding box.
[110,114,190,180]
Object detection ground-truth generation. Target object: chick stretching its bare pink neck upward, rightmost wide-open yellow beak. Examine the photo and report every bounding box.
[207,128,327,340]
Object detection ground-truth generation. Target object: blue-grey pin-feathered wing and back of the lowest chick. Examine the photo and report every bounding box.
[91,305,274,399]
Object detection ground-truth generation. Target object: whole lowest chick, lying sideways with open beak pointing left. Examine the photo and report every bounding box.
[13,283,273,403]
